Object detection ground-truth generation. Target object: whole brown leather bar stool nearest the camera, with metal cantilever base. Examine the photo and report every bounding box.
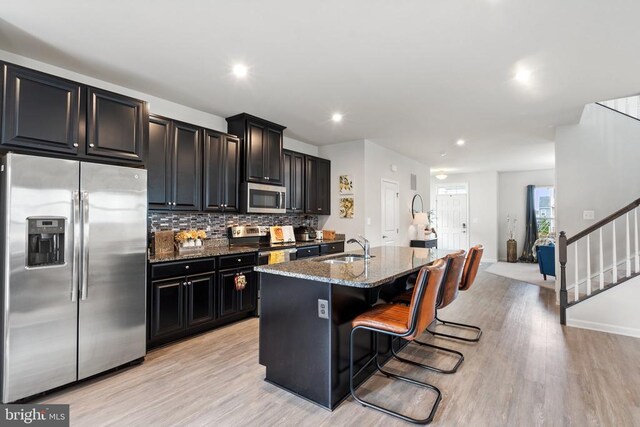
[349,260,446,424]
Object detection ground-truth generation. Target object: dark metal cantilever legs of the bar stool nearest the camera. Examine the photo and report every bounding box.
[349,326,442,424]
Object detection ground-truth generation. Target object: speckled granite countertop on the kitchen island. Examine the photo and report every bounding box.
[254,246,452,288]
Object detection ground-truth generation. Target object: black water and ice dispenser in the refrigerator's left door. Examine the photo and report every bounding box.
[27,217,65,267]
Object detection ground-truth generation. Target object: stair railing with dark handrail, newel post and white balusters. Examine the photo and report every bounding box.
[558,199,640,325]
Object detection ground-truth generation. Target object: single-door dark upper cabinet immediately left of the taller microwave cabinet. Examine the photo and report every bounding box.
[203,130,240,212]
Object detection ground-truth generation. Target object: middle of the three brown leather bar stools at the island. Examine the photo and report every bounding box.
[391,250,465,374]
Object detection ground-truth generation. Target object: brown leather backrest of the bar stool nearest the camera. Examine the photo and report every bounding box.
[404,259,446,340]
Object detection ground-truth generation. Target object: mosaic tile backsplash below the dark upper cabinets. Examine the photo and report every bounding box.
[148,212,318,239]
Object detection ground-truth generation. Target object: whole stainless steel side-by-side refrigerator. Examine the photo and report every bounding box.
[0,153,147,403]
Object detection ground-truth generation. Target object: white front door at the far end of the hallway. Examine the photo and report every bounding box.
[436,194,469,250]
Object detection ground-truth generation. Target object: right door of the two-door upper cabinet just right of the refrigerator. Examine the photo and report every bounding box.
[171,121,202,211]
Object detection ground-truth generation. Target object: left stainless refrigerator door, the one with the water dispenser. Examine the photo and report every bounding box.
[0,153,80,402]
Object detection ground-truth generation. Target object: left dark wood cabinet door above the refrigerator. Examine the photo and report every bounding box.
[0,64,86,155]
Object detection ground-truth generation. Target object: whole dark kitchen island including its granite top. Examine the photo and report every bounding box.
[255,246,449,410]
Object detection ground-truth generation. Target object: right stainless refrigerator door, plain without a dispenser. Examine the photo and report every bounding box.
[78,163,147,379]
